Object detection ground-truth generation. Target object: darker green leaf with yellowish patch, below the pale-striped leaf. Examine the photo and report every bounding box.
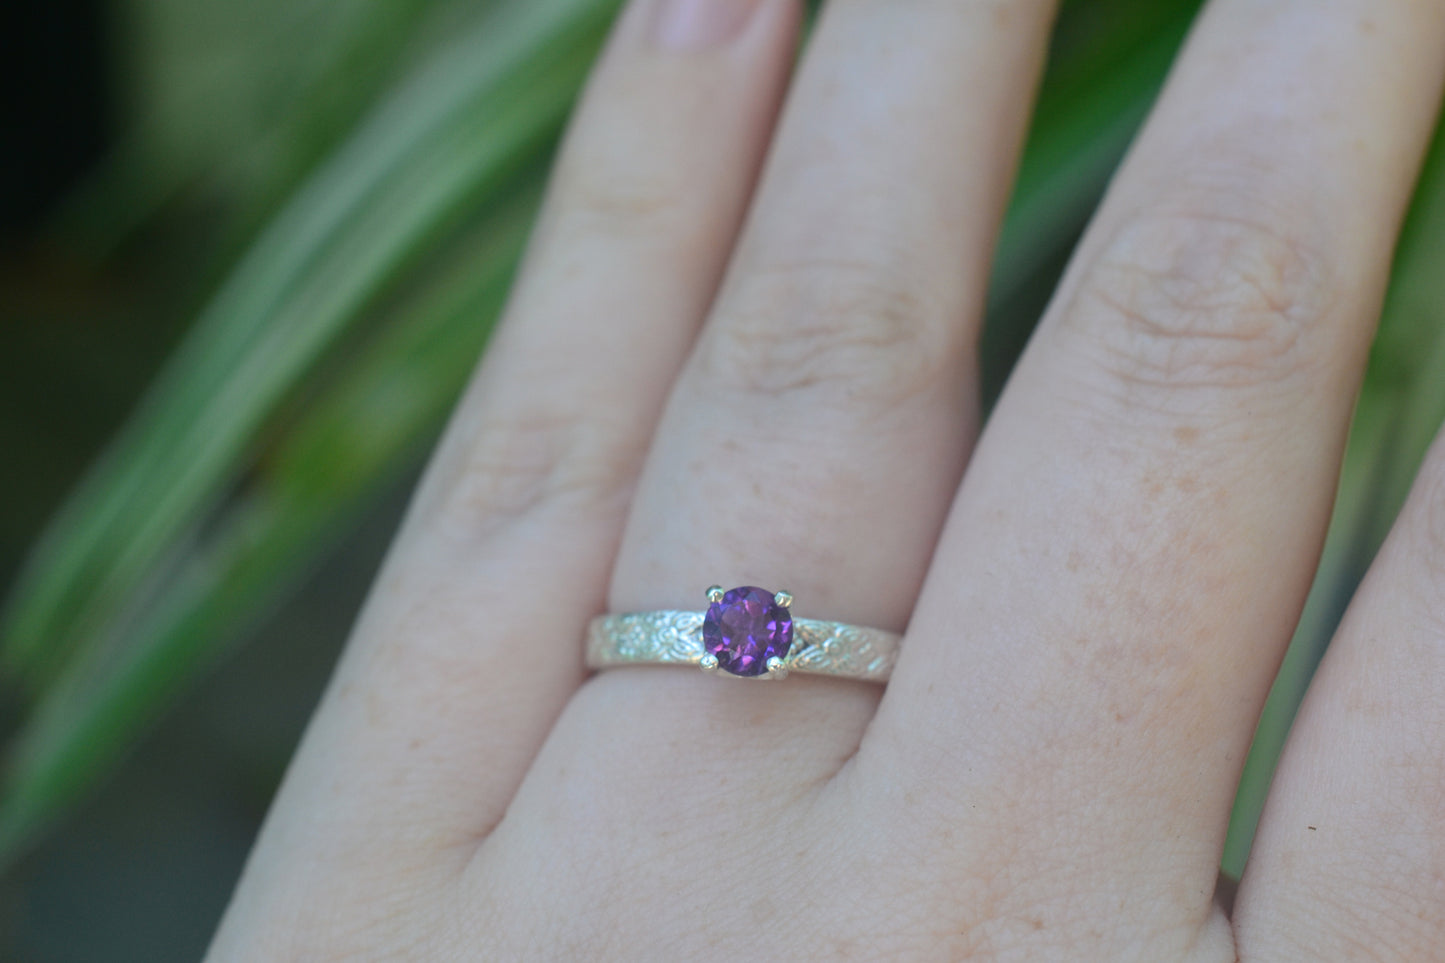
[0,178,540,863]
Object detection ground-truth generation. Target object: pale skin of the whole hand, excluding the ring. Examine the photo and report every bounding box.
[210,0,1445,963]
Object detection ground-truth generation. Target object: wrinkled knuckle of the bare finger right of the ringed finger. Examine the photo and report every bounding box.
[1065,175,1331,390]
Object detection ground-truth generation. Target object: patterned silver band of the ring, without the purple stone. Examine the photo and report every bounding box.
[587,612,902,682]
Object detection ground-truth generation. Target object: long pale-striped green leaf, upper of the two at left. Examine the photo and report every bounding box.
[0,0,613,688]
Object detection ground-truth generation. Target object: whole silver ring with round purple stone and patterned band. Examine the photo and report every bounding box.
[587,586,902,682]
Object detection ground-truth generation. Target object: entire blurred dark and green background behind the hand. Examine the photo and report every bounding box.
[0,0,1445,963]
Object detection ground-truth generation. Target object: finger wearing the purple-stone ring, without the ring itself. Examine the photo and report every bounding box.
[517,0,1051,827]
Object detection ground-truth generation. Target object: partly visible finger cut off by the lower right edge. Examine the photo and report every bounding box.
[1235,437,1445,960]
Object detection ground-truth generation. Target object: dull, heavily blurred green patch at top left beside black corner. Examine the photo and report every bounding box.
[52,0,479,257]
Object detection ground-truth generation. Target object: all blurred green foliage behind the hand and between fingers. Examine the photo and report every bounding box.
[0,0,1445,925]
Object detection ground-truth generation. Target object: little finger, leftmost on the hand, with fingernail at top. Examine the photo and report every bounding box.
[210,0,796,931]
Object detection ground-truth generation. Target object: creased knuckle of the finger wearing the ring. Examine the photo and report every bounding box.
[701,259,957,405]
